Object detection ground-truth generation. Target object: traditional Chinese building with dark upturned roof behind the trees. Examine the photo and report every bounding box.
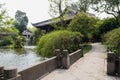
[32,4,78,32]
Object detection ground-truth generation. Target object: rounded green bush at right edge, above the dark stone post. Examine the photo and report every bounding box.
[104,28,120,56]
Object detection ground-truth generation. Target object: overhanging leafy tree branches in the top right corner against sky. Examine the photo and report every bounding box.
[91,0,120,26]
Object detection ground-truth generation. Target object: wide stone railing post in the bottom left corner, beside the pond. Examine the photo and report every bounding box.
[4,67,21,80]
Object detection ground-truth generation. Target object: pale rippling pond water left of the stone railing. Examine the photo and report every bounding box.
[0,46,41,71]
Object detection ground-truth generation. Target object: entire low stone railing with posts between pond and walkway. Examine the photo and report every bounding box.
[0,49,83,80]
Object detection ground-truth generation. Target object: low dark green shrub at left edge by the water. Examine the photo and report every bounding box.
[0,36,13,46]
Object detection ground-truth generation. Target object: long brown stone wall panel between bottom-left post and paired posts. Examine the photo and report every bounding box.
[19,57,57,80]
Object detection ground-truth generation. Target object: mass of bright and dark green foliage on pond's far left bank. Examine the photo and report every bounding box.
[0,27,23,48]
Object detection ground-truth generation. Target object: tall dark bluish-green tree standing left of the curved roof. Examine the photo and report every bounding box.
[15,10,28,34]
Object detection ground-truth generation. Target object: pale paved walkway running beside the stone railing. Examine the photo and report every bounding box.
[41,43,120,80]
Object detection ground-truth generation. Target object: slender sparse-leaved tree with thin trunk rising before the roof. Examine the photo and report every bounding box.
[49,0,70,27]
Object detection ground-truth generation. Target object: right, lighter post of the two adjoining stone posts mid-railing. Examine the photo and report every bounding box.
[62,50,70,69]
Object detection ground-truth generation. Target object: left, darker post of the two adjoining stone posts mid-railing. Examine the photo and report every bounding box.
[55,49,62,68]
